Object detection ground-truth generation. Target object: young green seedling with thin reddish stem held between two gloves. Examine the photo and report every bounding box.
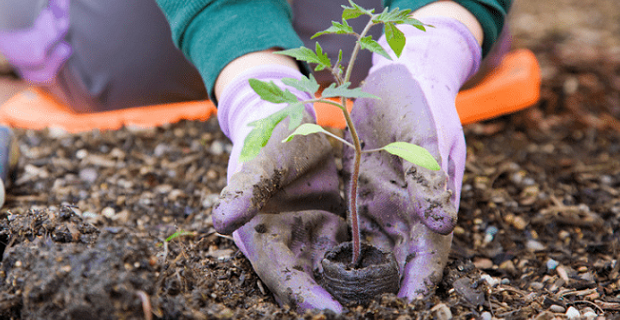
[240,0,440,266]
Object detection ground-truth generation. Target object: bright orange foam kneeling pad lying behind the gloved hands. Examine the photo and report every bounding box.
[0,50,540,133]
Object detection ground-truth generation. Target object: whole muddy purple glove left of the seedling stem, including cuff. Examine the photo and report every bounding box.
[213,66,347,312]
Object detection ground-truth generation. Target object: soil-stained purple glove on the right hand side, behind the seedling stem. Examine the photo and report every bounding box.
[343,18,481,299]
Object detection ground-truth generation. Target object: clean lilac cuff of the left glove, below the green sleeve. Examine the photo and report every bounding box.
[218,65,316,144]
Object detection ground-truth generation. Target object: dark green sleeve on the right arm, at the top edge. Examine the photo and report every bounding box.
[384,0,512,57]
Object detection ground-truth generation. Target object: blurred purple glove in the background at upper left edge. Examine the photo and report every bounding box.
[0,0,71,84]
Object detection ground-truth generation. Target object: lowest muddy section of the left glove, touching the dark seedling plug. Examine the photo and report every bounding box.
[233,210,349,314]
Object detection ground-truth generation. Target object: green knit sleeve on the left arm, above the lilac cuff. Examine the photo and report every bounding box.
[157,0,307,101]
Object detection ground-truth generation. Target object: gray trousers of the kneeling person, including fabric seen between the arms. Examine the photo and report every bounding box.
[0,0,381,112]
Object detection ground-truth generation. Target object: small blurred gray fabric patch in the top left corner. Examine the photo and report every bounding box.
[0,0,47,30]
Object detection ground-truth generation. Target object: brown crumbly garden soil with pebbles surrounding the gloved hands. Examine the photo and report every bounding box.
[0,0,620,320]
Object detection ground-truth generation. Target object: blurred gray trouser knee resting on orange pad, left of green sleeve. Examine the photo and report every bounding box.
[49,0,207,111]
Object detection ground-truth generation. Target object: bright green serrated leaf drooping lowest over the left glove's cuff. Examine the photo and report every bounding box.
[239,110,288,162]
